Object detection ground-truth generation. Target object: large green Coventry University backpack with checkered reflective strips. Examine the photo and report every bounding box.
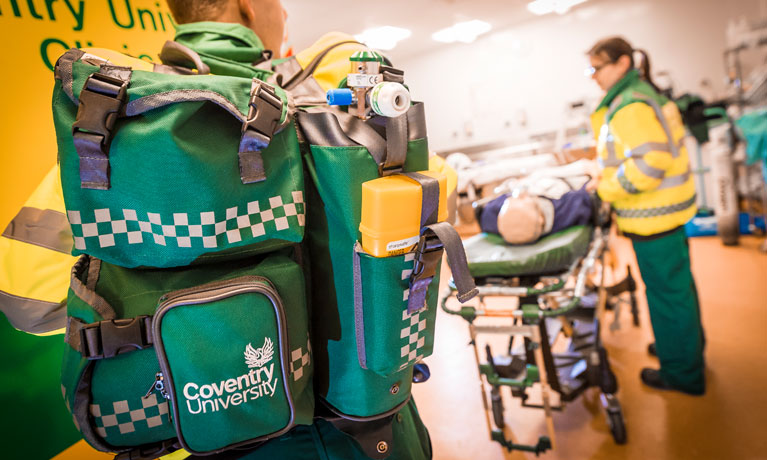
[53,42,473,458]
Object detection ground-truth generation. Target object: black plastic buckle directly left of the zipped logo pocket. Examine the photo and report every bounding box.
[80,315,154,360]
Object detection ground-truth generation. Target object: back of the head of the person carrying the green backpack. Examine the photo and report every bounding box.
[167,0,287,57]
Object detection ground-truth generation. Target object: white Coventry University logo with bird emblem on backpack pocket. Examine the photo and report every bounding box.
[183,337,279,414]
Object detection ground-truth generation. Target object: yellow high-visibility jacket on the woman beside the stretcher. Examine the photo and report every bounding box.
[591,70,696,236]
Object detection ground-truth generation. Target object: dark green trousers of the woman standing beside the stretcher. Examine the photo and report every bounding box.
[632,228,706,394]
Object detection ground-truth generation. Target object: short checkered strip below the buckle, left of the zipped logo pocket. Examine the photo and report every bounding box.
[90,393,170,438]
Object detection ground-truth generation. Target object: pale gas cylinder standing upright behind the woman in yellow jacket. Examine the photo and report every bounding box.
[703,123,740,246]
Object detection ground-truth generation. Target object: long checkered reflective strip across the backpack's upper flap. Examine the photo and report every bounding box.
[67,191,305,251]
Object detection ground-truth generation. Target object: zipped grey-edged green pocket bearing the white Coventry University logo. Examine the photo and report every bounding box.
[153,265,314,454]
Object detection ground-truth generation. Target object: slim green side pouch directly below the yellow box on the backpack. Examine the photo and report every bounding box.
[354,246,439,376]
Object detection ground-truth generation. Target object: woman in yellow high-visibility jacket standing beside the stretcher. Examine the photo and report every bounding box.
[587,37,705,395]
